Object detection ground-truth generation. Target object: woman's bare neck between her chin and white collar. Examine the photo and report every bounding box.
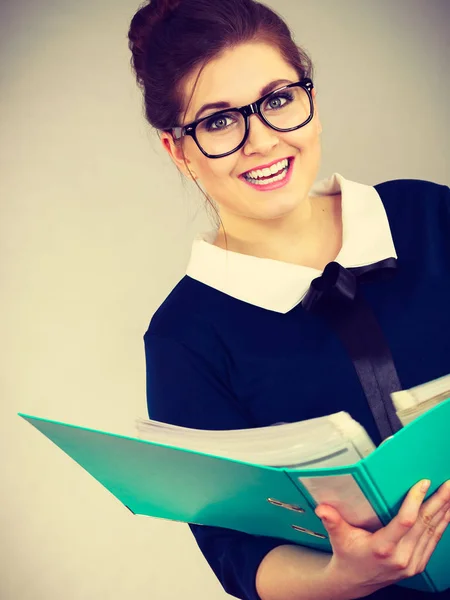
[214,194,342,269]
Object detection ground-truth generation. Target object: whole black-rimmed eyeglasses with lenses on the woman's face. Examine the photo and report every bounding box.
[171,78,314,158]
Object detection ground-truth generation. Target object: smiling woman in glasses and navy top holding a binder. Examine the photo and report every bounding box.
[129,0,450,600]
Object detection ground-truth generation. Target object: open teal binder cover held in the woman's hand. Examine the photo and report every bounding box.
[19,399,450,592]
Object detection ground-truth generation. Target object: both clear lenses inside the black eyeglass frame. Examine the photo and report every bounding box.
[196,87,311,155]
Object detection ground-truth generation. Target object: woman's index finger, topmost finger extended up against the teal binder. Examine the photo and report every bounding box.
[373,480,430,552]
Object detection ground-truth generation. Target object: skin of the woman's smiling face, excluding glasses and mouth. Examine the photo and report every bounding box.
[162,43,322,228]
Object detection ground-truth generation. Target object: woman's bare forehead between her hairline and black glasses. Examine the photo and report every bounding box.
[184,43,298,122]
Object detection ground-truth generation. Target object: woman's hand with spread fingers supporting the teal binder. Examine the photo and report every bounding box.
[316,480,450,600]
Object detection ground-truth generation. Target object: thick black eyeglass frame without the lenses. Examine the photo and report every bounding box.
[169,77,314,158]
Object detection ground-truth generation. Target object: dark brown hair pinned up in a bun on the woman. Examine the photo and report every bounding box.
[128,0,313,225]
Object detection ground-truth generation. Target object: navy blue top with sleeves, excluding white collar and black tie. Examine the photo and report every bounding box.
[144,180,450,600]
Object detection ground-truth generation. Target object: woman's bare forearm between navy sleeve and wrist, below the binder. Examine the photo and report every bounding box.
[256,545,347,600]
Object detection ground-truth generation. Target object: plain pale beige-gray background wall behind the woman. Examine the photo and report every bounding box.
[0,0,450,600]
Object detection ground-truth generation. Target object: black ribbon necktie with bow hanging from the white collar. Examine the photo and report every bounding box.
[302,258,402,440]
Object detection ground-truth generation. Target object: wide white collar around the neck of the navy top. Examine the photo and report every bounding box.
[186,173,397,314]
